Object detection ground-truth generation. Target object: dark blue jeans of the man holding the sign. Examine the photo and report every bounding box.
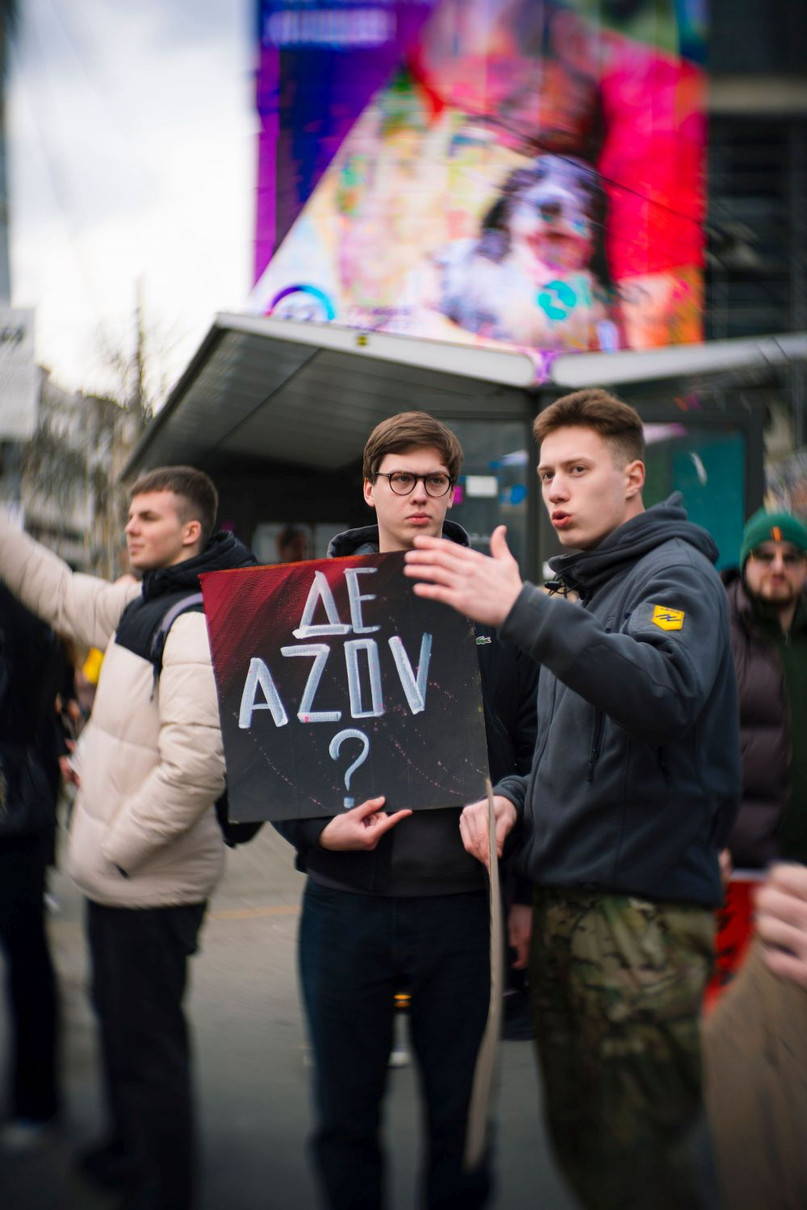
[299,880,491,1210]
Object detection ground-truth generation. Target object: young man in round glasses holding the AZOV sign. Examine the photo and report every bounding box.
[278,411,537,1210]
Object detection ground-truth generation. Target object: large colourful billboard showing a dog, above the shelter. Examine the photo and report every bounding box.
[250,0,705,380]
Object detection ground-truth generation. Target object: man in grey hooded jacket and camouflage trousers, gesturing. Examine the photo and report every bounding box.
[407,390,739,1210]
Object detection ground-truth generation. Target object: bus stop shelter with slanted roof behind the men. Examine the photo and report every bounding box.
[125,313,807,577]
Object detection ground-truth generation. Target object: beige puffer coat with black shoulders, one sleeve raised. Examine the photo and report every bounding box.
[0,515,224,908]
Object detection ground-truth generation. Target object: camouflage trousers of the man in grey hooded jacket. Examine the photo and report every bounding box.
[530,888,714,1210]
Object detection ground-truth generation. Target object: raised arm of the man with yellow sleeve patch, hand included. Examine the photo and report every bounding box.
[413,526,728,744]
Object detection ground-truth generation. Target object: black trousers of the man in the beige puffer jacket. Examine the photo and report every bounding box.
[87,901,206,1210]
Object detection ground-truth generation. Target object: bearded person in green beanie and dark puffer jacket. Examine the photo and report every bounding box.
[724,509,807,869]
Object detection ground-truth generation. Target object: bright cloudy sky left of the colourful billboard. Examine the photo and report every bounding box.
[8,0,255,401]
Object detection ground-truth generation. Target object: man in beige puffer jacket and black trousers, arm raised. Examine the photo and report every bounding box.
[0,467,255,1210]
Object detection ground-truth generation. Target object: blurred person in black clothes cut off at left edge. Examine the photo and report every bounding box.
[0,583,62,1151]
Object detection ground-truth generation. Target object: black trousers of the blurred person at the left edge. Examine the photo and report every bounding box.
[0,837,59,1122]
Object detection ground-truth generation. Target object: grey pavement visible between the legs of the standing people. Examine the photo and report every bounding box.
[0,826,573,1210]
